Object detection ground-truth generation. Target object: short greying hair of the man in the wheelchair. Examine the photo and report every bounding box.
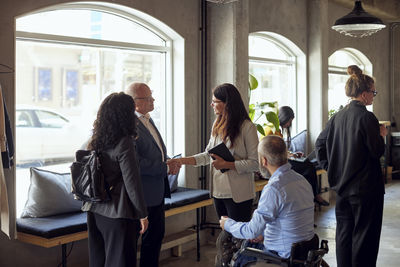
[258,135,287,167]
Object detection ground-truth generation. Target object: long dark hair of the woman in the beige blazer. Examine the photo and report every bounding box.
[212,83,250,145]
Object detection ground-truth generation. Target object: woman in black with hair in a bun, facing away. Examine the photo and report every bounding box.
[315,65,387,267]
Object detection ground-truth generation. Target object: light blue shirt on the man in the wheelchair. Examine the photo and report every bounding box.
[225,163,314,258]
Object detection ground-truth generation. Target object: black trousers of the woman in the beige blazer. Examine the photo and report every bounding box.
[214,198,253,222]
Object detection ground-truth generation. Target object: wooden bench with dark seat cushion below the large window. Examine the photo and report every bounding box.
[17,188,213,267]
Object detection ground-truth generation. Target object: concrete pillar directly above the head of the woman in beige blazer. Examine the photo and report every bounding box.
[207,0,249,106]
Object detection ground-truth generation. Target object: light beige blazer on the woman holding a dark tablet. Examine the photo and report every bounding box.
[193,120,259,203]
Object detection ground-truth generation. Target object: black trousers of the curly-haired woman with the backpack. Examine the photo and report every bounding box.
[87,212,139,267]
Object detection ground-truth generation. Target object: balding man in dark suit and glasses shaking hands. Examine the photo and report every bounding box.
[126,83,180,267]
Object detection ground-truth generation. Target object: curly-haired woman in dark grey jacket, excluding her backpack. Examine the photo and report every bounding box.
[82,92,148,267]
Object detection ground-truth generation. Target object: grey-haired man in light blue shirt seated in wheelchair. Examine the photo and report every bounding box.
[220,135,328,266]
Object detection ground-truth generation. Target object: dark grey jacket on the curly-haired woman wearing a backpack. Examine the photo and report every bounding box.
[82,136,147,219]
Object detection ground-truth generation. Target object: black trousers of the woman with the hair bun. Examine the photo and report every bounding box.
[336,193,383,267]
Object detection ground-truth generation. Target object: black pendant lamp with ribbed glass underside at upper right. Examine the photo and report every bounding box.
[332,1,386,37]
